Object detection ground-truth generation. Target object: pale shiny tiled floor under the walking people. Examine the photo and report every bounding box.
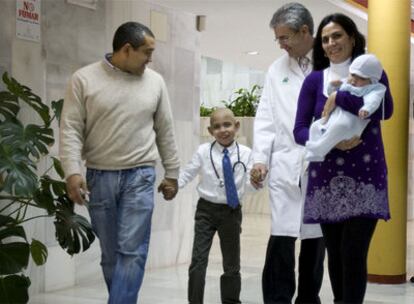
[30,214,414,304]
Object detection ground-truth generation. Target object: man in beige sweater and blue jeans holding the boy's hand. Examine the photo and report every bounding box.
[60,22,179,304]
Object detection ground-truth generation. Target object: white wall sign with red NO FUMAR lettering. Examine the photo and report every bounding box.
[16,0,41,42]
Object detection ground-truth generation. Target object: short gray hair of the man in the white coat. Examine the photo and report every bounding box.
[270,2,313,35]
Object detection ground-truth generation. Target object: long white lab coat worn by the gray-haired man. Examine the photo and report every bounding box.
[253,54,322,239]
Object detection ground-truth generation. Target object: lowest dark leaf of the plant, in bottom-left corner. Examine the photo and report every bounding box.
[0,275,30,304]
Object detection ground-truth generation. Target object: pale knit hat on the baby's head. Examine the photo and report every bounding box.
[349,54,382,83]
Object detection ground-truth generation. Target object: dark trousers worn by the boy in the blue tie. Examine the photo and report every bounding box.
[188,198,242,304]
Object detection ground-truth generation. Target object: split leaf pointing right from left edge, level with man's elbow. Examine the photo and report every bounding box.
[0,119,55,159]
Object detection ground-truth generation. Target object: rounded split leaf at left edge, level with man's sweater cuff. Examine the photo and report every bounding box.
[0,144,38,196]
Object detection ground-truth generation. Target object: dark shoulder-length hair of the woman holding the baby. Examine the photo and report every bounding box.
[312,13,365,71]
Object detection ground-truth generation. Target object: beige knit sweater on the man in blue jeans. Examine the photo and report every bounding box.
[59,61,179,178]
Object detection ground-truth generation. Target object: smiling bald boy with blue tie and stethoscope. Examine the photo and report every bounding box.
[178,108,253,304]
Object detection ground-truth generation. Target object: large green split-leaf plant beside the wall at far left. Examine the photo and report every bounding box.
[0,73,95,303]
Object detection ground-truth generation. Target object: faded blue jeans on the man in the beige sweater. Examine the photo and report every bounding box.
[86,167,155,304]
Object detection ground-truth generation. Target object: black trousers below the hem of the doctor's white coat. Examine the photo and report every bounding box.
[262,235,325,304]
